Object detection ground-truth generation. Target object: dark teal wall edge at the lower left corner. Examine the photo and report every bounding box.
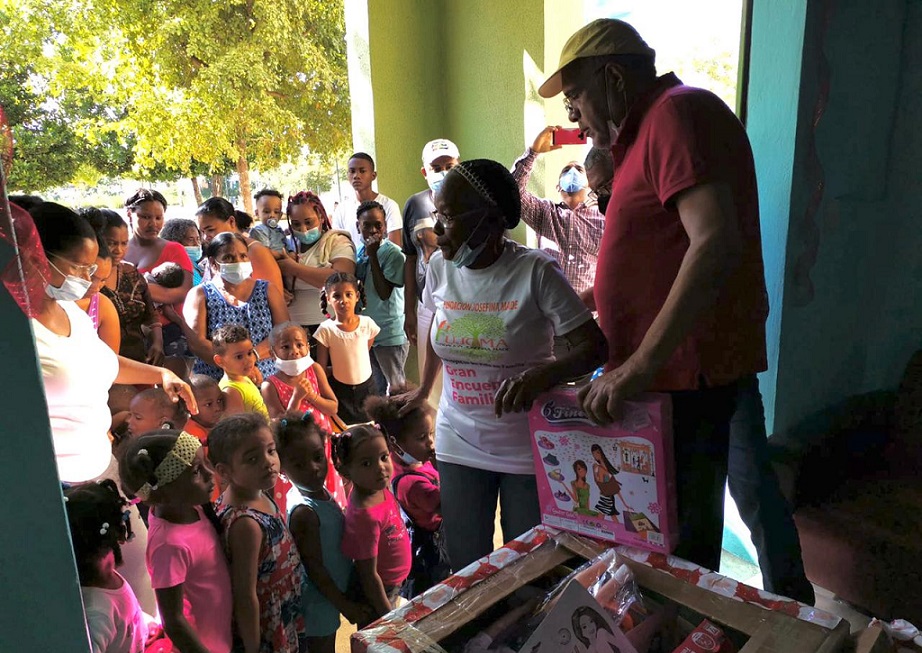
[0,245,89,653]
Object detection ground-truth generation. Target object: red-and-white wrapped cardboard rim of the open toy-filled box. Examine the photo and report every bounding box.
[351,526,848,653]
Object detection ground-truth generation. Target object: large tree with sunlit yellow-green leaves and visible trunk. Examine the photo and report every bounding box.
[54,0,351,212]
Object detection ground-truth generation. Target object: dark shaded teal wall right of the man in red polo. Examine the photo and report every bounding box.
[768,0,922,430]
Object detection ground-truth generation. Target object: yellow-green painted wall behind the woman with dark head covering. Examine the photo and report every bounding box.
[358,0,556,242]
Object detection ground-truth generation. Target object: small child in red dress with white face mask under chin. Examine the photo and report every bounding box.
[262,322,346,506]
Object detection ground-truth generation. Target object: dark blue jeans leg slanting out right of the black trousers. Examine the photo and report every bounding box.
[727,376,816,605]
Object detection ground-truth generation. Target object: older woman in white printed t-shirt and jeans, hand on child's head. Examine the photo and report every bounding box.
[398,159,607,569]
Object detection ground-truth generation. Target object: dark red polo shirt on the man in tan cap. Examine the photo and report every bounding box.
[595,73,768,391]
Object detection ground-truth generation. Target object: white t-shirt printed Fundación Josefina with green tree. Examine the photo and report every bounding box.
[423,240,592,474]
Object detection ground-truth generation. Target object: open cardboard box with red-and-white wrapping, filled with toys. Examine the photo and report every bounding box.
[351,526,848,653]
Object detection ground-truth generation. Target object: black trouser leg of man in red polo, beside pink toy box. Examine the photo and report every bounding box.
[669,383,737,571]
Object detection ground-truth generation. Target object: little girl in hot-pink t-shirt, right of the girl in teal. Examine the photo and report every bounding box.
[332,424,412,628]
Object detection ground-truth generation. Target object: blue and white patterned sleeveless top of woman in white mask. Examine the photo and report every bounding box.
[192,279,276,381]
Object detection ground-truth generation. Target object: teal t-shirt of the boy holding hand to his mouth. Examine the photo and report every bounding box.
[355,240,407,347]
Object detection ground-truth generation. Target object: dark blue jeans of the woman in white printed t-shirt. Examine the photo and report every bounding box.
[439,461,541,571]
